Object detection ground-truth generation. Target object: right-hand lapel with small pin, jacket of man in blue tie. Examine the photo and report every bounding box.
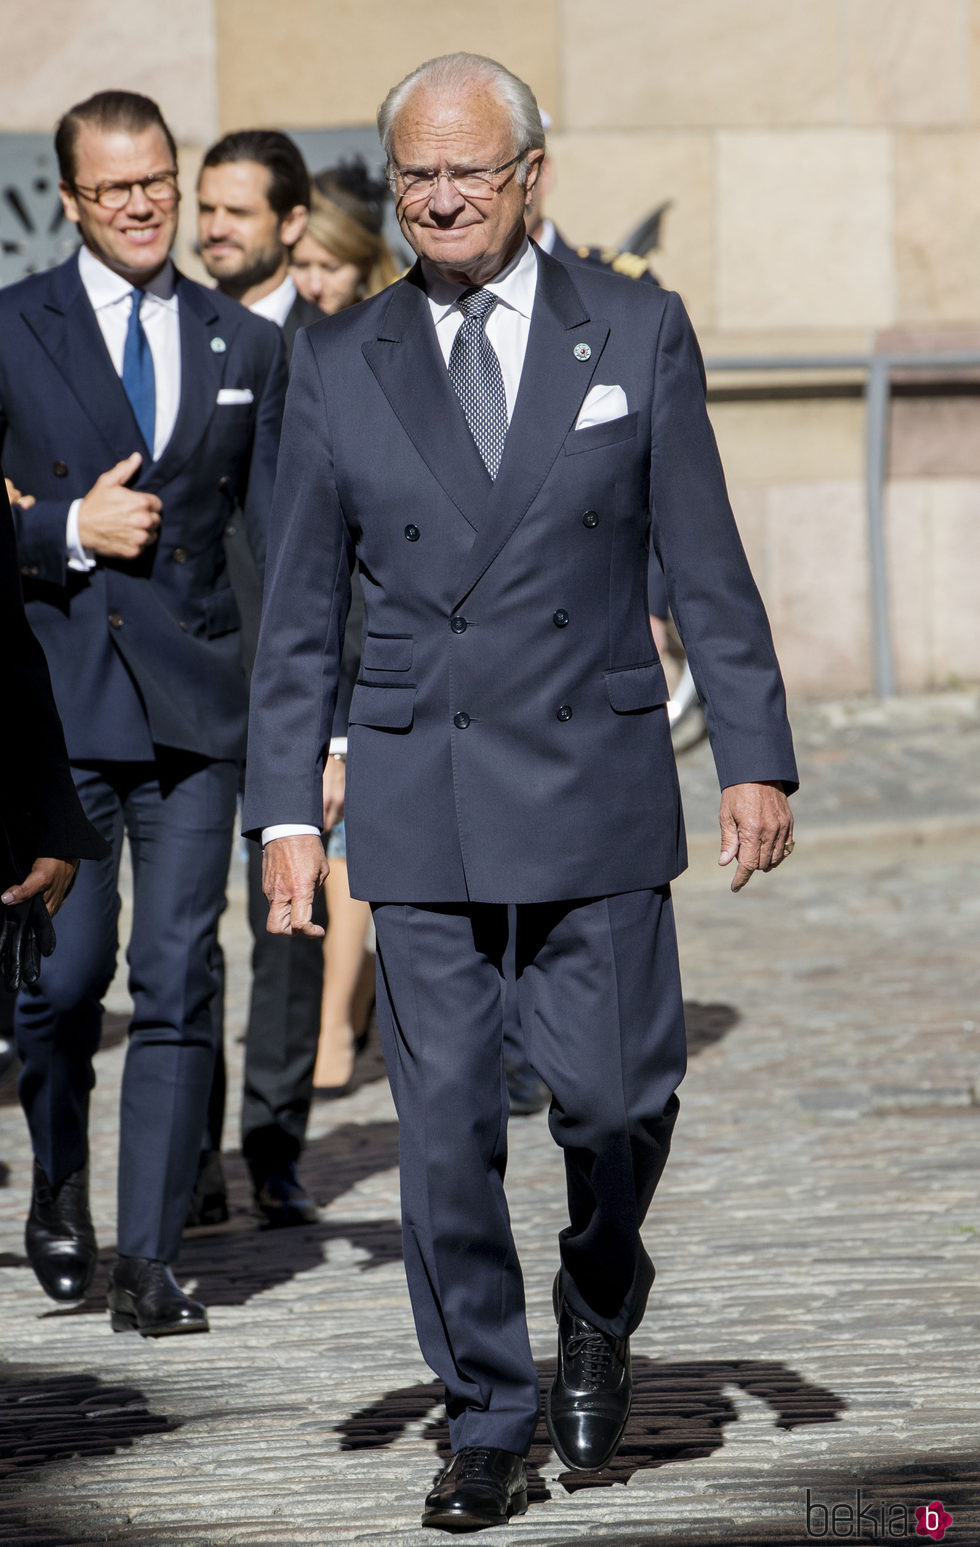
[139,274,226,489]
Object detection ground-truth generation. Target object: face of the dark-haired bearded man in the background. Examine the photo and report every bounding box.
[197,161,295,289]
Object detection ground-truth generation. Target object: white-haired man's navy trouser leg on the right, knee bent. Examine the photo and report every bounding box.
[517,886,686,1338]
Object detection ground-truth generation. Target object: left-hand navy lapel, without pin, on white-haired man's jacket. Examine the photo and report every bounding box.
[362,265,494,531]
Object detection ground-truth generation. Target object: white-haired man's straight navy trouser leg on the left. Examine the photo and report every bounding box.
[373,903,539,1454]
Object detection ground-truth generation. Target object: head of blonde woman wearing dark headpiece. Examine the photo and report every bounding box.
[290,159,401,314]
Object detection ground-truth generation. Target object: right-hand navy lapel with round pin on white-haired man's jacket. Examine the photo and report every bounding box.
[455,252,608,608]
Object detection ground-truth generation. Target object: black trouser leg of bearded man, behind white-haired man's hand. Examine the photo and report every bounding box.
[242,843,327,1171]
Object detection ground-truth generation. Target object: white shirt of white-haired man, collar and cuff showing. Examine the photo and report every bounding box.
[260,240,537,845]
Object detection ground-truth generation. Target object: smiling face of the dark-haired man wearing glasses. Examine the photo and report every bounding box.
[59,124,178,285]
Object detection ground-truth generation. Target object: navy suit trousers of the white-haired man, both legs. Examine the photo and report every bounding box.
[366,886,686,1454]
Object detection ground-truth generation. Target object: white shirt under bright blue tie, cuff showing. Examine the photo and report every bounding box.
[65,248,180,569]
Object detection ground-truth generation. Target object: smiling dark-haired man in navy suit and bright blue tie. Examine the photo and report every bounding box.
[0,91,285,1337]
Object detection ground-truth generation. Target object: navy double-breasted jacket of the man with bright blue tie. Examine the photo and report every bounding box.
[0,257,286,763]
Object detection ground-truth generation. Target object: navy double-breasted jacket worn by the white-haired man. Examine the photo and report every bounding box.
[245,245,796,902]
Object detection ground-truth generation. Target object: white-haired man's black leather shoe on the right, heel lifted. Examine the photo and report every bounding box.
[547,1278,633,1471]
